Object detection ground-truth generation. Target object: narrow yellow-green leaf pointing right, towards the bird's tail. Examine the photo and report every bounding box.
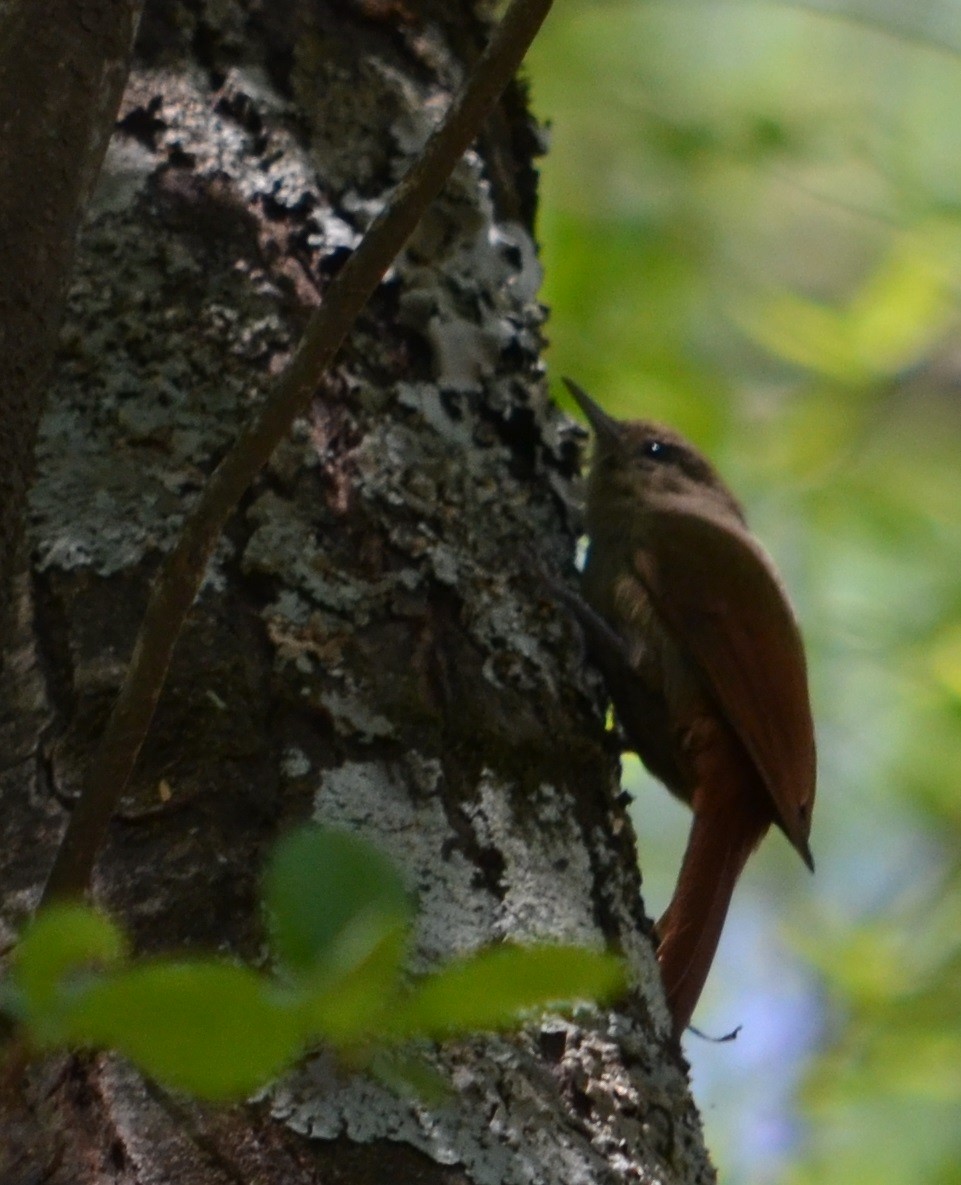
[390,946,624,1037]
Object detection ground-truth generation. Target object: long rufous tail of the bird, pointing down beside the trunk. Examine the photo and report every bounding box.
[658,768,771,1037]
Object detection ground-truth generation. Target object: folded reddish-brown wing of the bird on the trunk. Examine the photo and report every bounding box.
[635,508,816,866]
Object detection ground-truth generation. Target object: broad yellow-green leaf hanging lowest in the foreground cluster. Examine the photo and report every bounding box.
[64,960,302,1100]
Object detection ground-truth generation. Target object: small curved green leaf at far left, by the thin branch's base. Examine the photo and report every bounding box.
[13,904,124,1023]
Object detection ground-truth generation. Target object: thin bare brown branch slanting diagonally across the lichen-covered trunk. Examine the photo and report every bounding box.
[41,0,552,904]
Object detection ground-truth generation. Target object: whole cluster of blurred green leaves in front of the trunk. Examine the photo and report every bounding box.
[0,827,623,1100]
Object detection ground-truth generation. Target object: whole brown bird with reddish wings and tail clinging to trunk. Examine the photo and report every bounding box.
[565,379,815,1036]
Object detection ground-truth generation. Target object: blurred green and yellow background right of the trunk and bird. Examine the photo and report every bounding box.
[528,0,961,1185]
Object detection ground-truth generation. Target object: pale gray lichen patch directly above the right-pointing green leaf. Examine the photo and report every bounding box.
[314,754,670,1036]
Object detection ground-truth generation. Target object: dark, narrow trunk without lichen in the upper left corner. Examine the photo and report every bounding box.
[0,0,140,639]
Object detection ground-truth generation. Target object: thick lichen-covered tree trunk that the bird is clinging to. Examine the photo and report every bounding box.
[0,0,713,1185]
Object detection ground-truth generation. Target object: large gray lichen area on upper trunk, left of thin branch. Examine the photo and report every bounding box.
[32,48,391,575]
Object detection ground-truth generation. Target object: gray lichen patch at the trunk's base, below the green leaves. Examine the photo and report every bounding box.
[270,1008,713,1185]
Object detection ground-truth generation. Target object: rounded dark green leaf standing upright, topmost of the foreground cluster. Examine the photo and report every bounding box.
[264,827,411,976]
